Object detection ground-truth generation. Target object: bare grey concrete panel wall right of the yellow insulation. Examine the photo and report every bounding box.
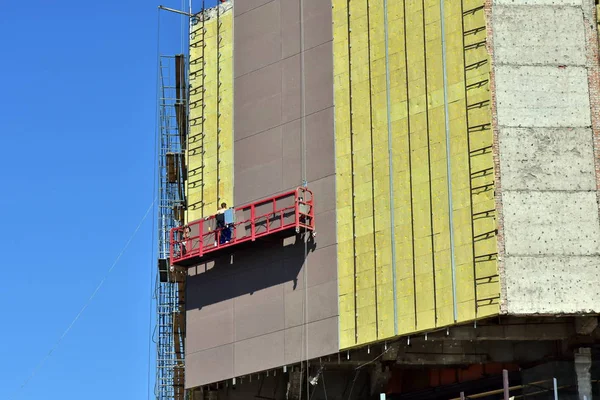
[492,0,600,314]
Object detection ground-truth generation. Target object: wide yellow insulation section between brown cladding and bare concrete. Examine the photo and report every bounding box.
[333,0,499,349]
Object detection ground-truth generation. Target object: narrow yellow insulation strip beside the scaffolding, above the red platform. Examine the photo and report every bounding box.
[186,10,233,221]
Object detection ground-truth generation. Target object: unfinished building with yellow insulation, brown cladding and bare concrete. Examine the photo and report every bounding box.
[156,0,600,399]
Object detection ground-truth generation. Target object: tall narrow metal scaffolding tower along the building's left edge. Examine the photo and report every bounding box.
[154,55,188,400]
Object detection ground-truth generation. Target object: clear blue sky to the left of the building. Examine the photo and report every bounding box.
[0,0,219,400]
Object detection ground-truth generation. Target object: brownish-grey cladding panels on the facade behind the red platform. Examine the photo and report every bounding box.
[186,0,339,388]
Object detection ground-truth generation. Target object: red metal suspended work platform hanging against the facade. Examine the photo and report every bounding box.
[170,187,316,265]
